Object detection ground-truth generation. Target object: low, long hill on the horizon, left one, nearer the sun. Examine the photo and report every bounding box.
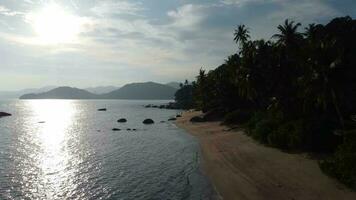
[20,87,99,99]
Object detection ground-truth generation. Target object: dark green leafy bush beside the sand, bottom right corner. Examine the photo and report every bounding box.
[320,130,356,189]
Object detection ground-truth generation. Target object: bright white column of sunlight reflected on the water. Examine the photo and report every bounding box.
[29,100,76,199]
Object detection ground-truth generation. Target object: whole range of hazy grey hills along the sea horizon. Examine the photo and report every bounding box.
[20,82,177,100]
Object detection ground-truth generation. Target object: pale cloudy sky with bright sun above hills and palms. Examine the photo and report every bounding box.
[0,0,356,90]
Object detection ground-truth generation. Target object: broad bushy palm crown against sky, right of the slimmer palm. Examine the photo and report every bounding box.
[272,19,302,47]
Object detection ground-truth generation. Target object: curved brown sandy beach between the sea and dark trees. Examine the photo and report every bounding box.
[176,112,356,200]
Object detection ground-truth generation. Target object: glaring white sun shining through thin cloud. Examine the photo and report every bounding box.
[31,4,82,44]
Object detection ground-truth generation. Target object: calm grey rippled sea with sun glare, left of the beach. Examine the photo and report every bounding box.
[0,100,213,200]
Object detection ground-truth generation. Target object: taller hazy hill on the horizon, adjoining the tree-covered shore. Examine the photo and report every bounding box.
[102,82,177,99]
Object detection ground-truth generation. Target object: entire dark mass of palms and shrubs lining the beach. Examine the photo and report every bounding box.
[176,17,356,186]
